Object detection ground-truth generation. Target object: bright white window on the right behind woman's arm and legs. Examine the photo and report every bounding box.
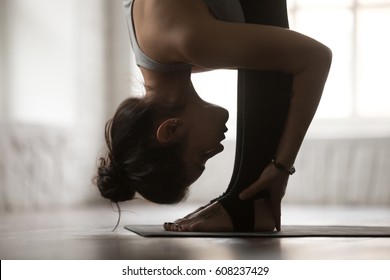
[195,0,390,138]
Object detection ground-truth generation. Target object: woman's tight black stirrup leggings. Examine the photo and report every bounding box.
[219,0,292,231]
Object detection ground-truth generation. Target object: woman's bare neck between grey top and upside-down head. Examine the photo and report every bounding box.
[141,68,194,105]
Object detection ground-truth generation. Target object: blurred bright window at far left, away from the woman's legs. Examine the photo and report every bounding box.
[0,0,77,124]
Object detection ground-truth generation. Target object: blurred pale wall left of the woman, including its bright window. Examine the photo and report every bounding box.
[0,0,132,212]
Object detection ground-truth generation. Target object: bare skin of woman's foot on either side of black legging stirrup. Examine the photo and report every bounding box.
[164,199,275,232]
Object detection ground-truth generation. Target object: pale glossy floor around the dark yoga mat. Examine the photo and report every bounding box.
[0,203,390,260]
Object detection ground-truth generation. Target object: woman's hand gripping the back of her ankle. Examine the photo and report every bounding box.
[240,164,289,231]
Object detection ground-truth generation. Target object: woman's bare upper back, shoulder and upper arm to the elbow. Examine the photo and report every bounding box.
[134,0,323,73]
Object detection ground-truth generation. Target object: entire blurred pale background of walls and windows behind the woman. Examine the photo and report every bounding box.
[0,0,390,213]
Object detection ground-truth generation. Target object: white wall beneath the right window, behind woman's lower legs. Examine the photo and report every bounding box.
[189,135,390,206]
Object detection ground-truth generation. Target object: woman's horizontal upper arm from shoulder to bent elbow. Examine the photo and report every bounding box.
[178,20,324,74]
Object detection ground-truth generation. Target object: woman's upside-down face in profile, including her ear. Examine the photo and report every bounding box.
[157,91,229,197]
